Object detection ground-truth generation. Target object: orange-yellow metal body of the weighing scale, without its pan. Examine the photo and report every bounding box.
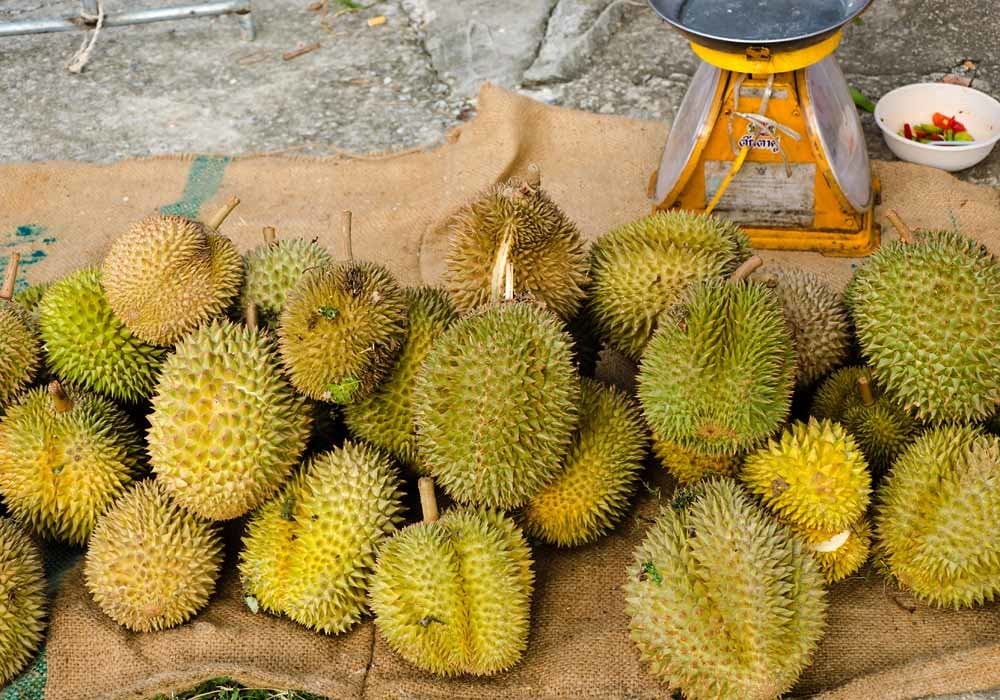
[654,32,880,257]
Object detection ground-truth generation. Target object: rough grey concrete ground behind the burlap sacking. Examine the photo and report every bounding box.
[0,0,1000,700]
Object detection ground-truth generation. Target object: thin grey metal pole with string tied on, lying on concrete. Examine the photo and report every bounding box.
[0,0,256,41]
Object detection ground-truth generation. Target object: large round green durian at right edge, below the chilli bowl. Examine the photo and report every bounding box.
[846,231,1000,423]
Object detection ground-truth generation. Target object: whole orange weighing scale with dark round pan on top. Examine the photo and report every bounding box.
[649,0,880,256]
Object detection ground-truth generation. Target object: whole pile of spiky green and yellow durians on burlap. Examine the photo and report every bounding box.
[0,170,1000,700]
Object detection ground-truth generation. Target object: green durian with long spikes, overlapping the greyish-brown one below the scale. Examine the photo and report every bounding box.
[639,279,795,455]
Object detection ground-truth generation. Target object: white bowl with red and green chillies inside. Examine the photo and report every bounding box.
[875,83,1000,171]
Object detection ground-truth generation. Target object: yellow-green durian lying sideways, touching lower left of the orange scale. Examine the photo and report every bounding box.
[590,211,750,360]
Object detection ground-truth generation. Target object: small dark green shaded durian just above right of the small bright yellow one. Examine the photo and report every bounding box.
[811,367,921,478]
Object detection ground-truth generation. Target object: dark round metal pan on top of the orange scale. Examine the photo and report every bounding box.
[649,0,872,52]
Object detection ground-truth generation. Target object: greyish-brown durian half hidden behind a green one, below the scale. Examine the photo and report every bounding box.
[754,268,851,387]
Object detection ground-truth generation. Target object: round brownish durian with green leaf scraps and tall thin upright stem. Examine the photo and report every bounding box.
[278,262,407,404]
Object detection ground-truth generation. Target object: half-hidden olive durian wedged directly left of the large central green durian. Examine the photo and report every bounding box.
[344,287,458,472]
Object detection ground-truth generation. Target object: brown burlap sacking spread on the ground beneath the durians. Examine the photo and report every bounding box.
[0,87,1000,700]
